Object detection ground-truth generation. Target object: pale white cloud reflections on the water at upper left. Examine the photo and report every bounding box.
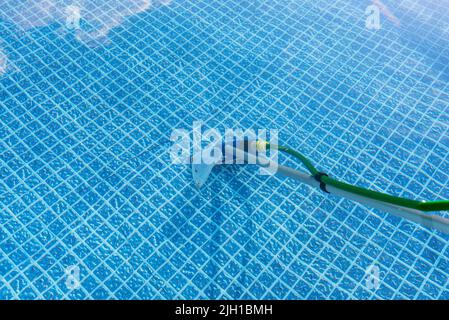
[0,0,171,75]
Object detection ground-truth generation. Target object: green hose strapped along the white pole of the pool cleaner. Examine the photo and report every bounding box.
[265,142,449,212]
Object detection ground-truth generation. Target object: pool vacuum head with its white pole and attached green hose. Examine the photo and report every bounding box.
[192,140,449,234]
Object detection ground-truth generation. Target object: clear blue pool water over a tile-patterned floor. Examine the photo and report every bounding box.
[0,0,449,299]
